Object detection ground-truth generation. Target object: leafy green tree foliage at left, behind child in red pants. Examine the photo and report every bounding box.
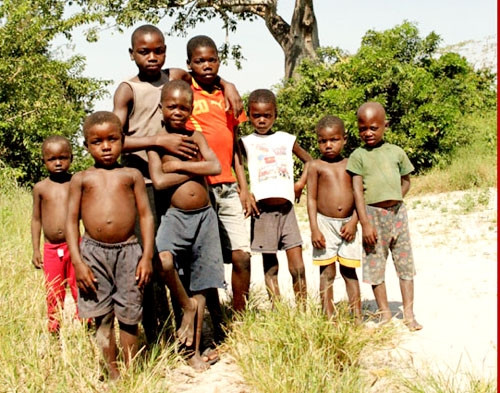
[0,0,109,184]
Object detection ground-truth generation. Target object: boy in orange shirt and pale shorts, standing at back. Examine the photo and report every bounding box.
[187,36,252,312]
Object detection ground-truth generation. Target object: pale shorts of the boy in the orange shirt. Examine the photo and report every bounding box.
[209,183,250,263]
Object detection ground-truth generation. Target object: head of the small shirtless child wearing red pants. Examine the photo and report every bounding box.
[42,135,73,175]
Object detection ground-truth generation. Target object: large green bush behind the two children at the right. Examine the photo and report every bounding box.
[277,22,496,170]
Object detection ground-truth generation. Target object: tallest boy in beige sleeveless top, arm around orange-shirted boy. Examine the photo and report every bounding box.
[113,25,242,343]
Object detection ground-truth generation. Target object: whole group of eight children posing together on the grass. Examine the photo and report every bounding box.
[32,25,421,378]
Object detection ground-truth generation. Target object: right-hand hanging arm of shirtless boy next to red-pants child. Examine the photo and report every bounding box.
[134,171,154,289]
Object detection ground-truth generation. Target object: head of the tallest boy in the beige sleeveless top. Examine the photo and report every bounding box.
[129,25,167,76]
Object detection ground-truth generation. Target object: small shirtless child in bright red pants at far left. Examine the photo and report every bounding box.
[31,135,78,333]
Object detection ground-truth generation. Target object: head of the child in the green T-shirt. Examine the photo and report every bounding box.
[356,102,388,147]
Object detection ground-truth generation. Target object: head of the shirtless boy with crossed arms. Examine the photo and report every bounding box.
[160,79,193,130]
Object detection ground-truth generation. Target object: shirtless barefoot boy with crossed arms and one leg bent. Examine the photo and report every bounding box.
[148,80,224,369]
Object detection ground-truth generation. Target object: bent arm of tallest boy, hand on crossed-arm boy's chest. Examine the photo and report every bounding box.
[113,83,198,158]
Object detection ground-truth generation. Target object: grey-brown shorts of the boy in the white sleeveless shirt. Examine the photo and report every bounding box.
[252,202,302,254]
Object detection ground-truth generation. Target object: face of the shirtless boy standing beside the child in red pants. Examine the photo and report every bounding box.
[85,123,123,167]
